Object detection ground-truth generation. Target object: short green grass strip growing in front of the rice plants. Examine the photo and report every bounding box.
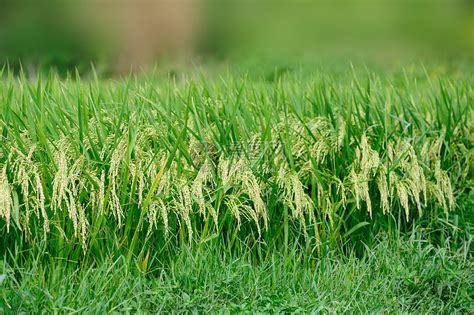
[0,236,474,313]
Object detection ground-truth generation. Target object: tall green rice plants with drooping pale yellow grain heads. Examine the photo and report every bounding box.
[0,66,474,269]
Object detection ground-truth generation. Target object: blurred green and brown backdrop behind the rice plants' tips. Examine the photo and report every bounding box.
[0,0,474,75]
